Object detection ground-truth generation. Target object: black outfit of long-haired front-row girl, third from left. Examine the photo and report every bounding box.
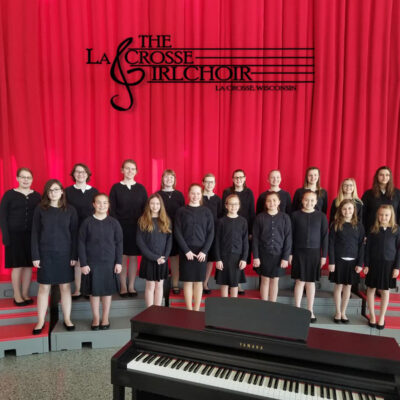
[136,218,172,282]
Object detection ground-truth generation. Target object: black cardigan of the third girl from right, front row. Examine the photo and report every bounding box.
[292,210,328,257]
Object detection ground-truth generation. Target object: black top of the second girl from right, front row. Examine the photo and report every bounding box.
[329,222,365,266]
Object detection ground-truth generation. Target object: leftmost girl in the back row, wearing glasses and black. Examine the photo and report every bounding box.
[0,168,40,306]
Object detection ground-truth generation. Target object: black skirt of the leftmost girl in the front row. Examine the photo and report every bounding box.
[37,251,74,285]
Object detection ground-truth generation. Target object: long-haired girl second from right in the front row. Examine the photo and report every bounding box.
[329,199,365,323]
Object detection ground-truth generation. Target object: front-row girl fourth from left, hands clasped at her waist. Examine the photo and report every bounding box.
[174,183,214,311]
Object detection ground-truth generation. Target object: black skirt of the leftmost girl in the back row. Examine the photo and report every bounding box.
[5,232,32,268]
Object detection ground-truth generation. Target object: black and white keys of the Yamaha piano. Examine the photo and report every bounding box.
[127,352,384,400]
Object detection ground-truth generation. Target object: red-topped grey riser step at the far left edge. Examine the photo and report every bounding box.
[0,322,49,358]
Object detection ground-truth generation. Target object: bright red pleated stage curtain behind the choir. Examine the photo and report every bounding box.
[0,0,400,272]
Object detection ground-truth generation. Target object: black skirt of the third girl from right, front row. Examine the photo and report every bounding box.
[292,249,321,282]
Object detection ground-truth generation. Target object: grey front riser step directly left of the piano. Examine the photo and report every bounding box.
[50,317,131,351]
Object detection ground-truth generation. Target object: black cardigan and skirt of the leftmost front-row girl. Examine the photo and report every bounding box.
[32,206,78,284]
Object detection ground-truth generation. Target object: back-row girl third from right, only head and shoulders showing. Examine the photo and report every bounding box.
[292,167,328,214]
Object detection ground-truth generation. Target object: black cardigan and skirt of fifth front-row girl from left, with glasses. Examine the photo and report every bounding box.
[215,216,249,287]
